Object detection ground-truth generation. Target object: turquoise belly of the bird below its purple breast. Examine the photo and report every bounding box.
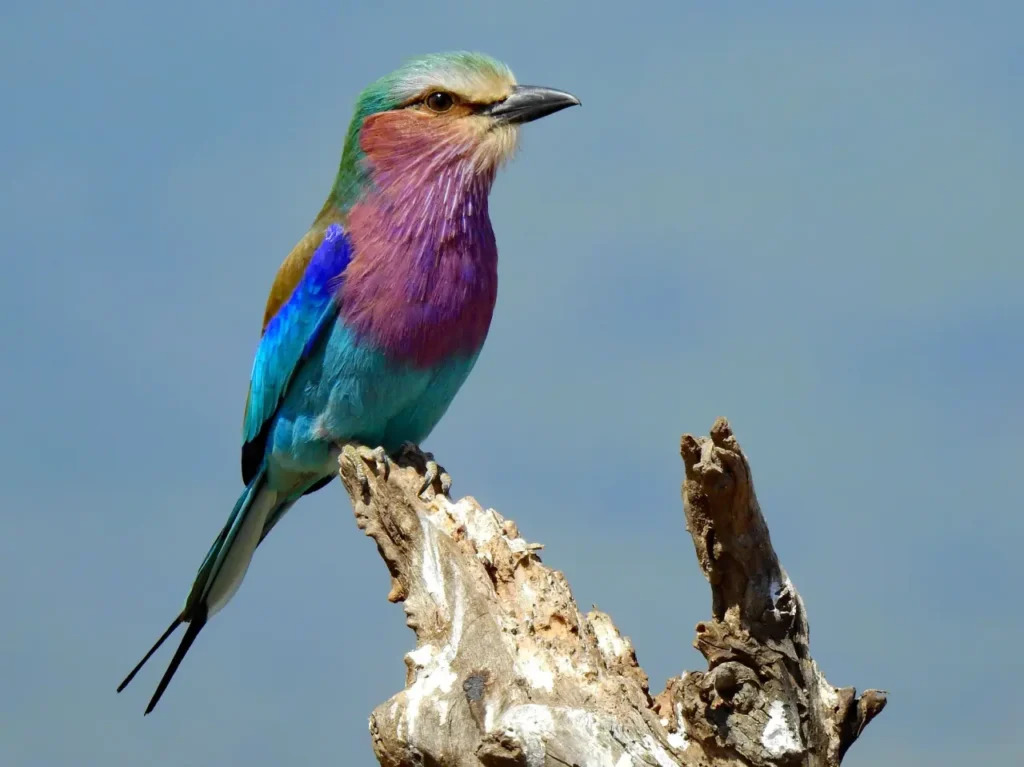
[267,322,478,476]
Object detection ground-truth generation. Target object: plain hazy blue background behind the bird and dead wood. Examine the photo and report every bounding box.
[0,0,1024,767]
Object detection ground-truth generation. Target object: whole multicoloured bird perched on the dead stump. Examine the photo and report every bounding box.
[118,51,581,715]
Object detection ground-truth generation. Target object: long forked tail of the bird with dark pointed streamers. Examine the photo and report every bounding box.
[118,467,278,714]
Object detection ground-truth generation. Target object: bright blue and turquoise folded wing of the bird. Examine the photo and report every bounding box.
[242,218,352,484]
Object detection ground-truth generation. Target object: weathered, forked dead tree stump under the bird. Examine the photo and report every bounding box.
[341,419,886,767]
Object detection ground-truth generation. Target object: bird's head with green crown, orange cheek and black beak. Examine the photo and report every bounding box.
[334,52,580,207]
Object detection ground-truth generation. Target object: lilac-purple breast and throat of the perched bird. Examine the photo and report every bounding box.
[341,173,498,368]
